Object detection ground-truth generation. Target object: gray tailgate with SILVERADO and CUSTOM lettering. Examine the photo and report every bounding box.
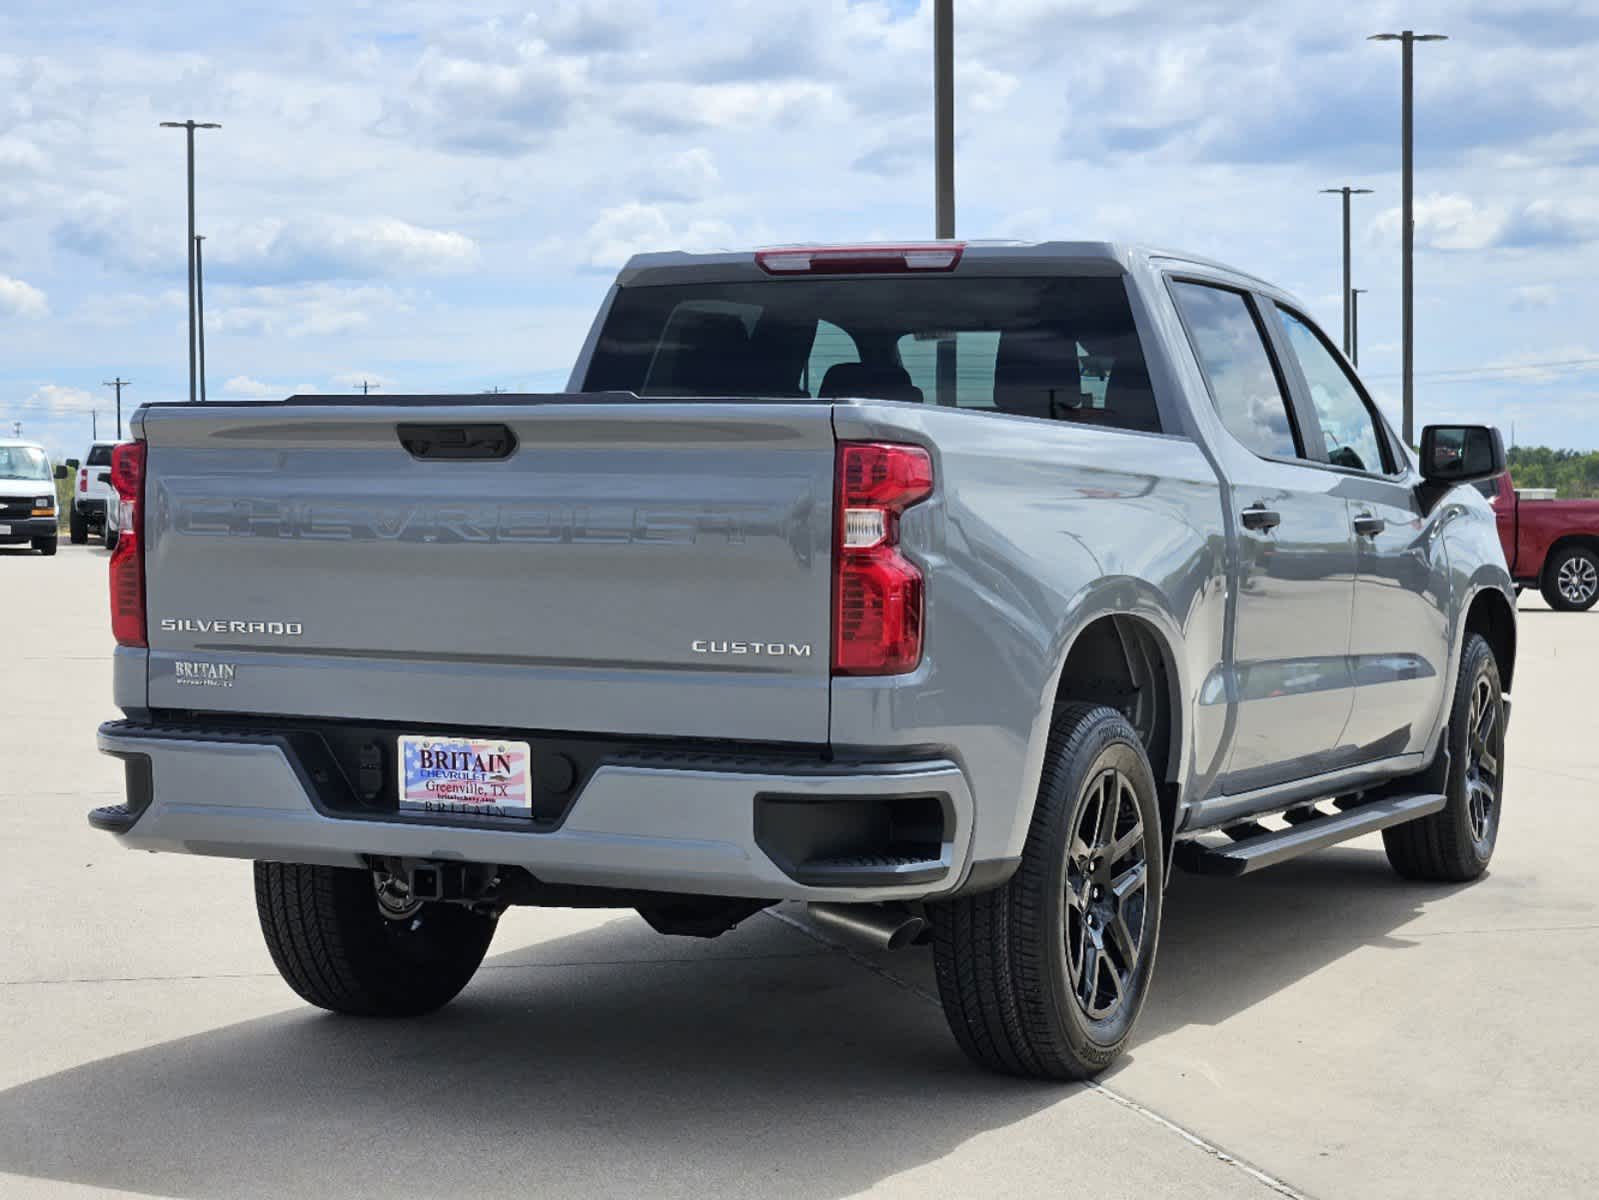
[142,397,833,742]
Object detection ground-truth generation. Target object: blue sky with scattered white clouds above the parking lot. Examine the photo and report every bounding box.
[0,0,1599,456]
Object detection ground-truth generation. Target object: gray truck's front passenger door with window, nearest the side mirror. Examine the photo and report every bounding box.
[1273,306,1450,765]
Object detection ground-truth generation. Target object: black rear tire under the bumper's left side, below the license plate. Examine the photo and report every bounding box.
[256,862,496,1016]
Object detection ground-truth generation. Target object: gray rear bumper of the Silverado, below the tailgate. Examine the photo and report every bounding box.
[91,722,972,901]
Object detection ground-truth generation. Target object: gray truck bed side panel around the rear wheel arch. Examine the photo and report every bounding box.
[831,402,1228,859]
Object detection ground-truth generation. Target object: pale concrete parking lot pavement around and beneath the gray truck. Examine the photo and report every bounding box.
[0,546,1599,1200]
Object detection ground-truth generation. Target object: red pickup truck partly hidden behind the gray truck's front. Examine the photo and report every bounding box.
[1476,475,1599,613]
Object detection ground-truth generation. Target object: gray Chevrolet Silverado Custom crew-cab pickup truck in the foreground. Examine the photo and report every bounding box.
[90,242,1516,1078]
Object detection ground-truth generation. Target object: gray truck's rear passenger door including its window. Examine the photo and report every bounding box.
[1172,282,1356,794]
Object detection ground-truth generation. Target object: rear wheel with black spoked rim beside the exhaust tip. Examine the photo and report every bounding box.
[927,704,1166,1080]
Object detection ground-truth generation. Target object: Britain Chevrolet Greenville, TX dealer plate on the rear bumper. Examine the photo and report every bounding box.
[400,736,532,819]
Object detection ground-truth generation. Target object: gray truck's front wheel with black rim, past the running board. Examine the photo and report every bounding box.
[1383,634,1505,883]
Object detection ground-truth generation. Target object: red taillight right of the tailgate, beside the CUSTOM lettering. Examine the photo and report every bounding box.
[833,442,932,675]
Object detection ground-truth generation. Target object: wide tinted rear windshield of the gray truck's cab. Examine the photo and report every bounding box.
[584,275,1161,432]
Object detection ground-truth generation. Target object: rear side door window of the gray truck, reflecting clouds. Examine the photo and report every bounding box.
[1172,282,1300,458]
